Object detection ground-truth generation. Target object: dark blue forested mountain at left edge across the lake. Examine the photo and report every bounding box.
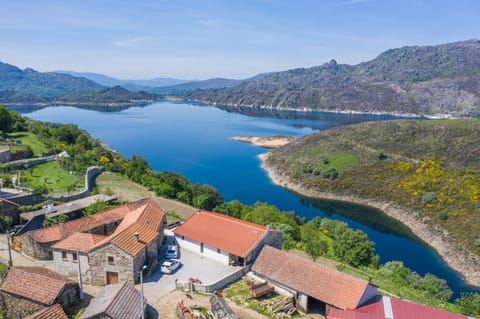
[0,62,159,106]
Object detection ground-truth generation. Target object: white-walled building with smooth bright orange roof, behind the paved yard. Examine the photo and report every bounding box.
[173,211,282,266]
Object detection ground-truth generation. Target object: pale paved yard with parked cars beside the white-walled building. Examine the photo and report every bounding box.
[136,234,238,308]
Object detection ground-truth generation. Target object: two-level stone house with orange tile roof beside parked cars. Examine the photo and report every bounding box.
[50,200,165,285]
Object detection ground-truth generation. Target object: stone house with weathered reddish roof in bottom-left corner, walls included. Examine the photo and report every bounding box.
[0,267,79,319]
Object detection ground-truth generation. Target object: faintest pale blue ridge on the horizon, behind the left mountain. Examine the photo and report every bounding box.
[55,71,190,91]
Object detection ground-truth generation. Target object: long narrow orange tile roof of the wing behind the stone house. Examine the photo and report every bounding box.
[25,206,130,243]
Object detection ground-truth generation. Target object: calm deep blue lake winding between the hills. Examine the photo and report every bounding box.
[10,102,478,296]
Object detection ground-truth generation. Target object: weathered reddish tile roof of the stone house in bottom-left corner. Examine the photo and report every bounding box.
[0,267,75,306]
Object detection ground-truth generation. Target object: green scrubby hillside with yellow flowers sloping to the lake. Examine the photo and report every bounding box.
[269,119,480,254]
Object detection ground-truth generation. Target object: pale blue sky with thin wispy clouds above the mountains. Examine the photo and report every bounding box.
[0,0,480,79]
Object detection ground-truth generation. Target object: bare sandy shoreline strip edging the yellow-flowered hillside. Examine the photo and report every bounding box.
[259,153,480,287]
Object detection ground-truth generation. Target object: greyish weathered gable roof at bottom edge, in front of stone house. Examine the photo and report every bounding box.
[80,281,147,319]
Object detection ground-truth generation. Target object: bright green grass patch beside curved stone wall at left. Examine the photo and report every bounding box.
[21,161,85,192]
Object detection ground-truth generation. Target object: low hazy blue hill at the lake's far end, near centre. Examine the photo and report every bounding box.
[150,78,244,95]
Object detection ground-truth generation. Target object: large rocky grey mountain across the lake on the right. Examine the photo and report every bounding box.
[186,40,480,117]
